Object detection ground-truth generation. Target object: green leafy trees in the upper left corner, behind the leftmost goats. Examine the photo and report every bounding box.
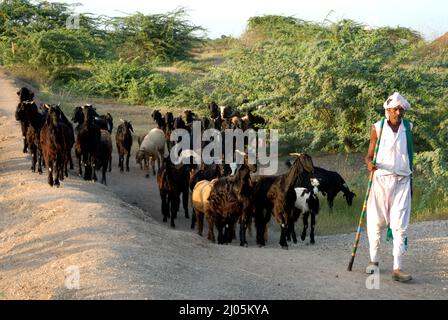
[0,0,110,67]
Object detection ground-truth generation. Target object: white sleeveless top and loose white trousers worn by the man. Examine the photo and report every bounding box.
[367,121,412,270]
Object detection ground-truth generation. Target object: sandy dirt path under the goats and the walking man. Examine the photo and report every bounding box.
[0,70,448,299]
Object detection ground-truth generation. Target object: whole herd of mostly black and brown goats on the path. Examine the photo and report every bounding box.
[15,88,355,248]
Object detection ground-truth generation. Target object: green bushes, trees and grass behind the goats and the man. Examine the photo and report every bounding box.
[0,0,448,232]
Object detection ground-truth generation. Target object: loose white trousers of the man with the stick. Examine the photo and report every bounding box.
[367,174,411,270]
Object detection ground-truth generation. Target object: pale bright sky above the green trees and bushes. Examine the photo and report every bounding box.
[58,0,448,40]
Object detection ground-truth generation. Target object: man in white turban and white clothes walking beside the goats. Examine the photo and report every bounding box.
[365,92,414,282]
